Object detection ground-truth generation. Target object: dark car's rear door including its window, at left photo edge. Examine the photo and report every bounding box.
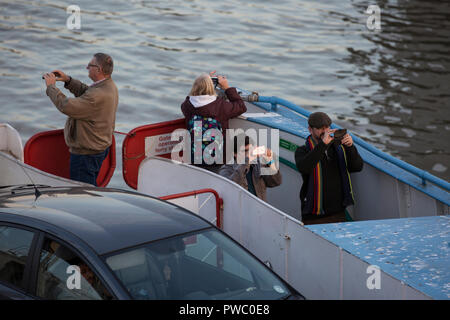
[0,222,38,300]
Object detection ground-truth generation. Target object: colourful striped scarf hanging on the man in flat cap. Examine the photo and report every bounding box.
[305,136,355,215]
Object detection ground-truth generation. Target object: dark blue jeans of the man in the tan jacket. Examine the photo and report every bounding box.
[70,147,109,186]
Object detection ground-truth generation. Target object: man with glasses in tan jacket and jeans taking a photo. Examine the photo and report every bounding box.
[44,53,119,186]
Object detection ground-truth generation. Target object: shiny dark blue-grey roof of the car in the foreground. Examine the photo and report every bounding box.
[0,187,211,255]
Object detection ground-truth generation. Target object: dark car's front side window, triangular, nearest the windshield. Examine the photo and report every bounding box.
[36,239,112,300]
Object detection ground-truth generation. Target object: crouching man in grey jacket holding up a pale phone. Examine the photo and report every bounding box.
[219,136,281,201]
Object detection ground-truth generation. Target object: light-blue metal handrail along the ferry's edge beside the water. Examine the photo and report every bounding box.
[253,96,450,191]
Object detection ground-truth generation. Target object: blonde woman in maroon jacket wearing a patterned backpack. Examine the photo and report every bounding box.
[181,72,247,173]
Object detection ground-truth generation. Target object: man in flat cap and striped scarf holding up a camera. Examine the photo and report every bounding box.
[295,112,363,224]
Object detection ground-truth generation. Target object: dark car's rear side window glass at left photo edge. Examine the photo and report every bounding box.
[0,226,34,289]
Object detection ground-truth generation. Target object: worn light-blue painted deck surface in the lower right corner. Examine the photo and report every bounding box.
[306,216,450,299]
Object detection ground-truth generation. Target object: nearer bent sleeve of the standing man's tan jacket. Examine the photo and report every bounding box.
[46,85,95,120]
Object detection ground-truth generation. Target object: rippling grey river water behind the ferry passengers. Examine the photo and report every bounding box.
[0,0,450,186]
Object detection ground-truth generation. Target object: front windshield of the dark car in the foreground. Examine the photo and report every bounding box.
[106,229,291,300]
